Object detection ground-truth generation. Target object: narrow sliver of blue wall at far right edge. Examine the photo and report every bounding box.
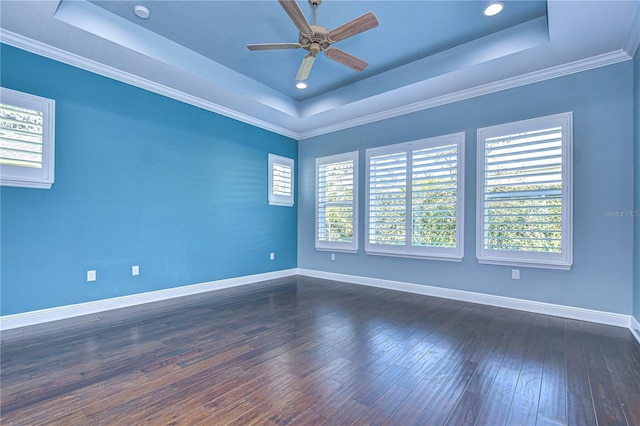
[633,49,640,322]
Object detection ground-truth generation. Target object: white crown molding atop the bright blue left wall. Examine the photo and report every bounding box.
[0,28,300,140]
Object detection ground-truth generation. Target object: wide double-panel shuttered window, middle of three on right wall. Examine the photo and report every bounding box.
[365,133,464,261]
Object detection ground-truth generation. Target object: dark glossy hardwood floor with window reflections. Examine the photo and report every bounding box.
[0,277,640,426]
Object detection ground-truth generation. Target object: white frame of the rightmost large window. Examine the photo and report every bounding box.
[476,112,573,270]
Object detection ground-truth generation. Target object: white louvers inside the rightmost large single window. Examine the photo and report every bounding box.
[482,127,564,253]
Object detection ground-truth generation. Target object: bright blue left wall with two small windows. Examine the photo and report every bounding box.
[0,45,297,315]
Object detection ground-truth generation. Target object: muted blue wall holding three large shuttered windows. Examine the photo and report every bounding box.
[298,61,634,315]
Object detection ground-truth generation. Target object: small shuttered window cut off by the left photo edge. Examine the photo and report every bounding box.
[0,87,55,189]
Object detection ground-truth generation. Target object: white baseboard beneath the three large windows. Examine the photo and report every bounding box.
[298,268,637,330]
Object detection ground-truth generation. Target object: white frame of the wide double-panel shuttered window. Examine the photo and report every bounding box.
[364,132,465,262]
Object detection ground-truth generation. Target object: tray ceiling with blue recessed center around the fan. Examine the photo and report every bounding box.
[0,0,640,139]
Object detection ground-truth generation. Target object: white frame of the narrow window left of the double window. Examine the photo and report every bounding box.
[314,151,359,253]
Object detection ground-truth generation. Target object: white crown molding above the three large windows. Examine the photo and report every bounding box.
[299,49,632,140]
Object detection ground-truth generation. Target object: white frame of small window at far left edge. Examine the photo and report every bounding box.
[0,87,55,189]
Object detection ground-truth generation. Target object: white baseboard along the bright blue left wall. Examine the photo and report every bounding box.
[0,269,297,331]
